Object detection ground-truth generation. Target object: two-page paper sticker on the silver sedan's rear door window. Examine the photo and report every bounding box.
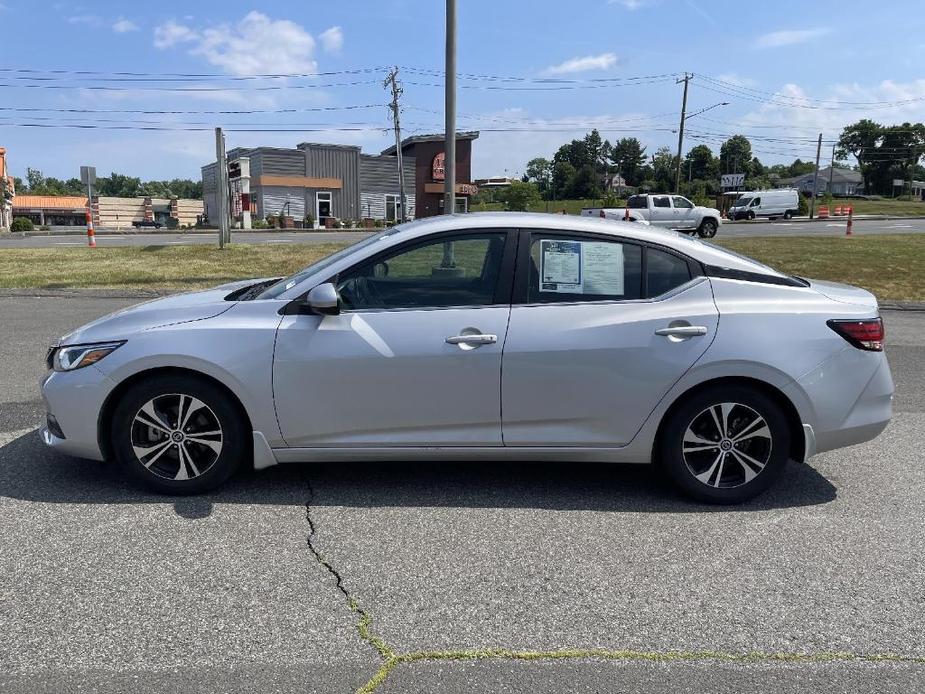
[540,239,625,296]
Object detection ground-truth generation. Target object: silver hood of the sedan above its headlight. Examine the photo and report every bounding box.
[58,280,268,345]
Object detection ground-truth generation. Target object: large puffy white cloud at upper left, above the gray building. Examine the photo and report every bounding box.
[154,11,317,75]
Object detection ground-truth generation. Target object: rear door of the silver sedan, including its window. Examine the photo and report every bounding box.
[501,231,718,447]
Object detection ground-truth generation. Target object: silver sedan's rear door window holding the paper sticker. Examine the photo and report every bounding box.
[527,234,642,303]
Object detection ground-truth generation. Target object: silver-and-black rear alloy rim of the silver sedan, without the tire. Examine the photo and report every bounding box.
[681,402,772,489]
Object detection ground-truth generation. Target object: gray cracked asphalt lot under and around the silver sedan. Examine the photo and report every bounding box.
[0,297,925,694]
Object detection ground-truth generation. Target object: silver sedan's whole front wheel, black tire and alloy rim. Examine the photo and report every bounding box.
[110,375,251,495]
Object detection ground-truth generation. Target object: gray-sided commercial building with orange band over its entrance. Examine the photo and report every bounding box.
[202,142,415,226]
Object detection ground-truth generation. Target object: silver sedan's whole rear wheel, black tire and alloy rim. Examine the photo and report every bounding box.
[656,386,790,504]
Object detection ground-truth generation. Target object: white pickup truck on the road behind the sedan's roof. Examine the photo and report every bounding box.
[581,194,721,239]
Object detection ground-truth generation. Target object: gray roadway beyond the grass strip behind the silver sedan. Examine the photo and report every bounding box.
[0,218,925,249]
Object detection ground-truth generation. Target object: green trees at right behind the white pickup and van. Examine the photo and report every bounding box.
[523,120,925,200]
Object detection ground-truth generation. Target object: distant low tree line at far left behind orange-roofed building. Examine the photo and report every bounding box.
[13,168,202,200]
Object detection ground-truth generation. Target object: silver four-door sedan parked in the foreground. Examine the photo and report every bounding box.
[42,213,893,503]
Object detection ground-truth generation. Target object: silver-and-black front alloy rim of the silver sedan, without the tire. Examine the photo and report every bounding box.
[130,393,223,480]
